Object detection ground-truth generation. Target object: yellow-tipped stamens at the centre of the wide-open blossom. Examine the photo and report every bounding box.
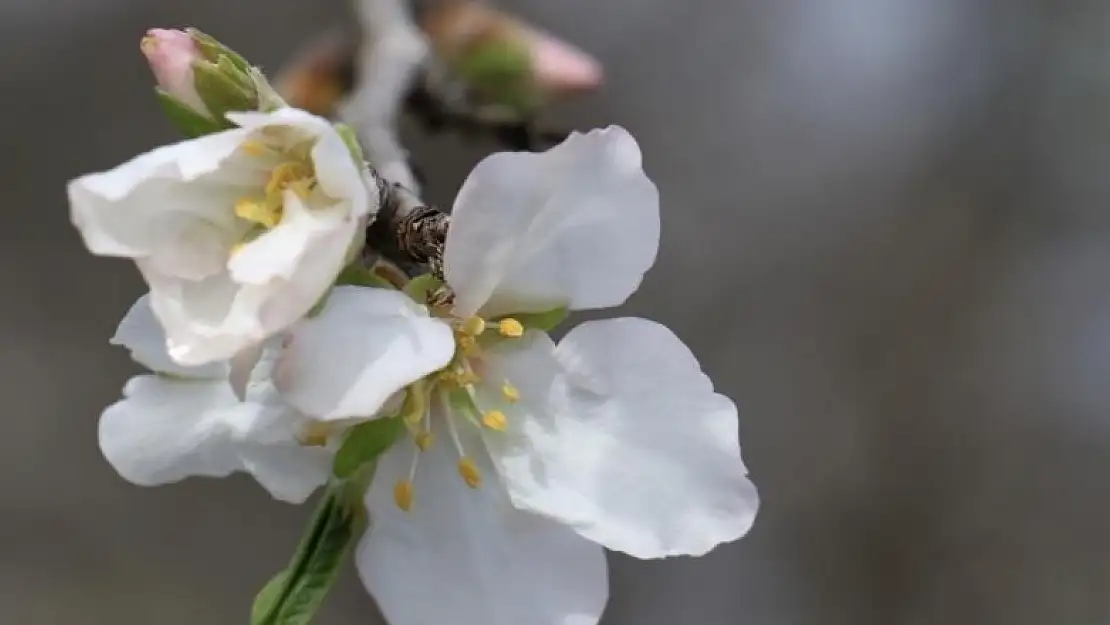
[393,316,524,512]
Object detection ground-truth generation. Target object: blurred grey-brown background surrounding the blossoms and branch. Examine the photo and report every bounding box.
[0,0,1110,625]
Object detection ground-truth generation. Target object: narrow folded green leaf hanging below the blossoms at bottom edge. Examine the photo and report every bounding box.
[251,484,366,625]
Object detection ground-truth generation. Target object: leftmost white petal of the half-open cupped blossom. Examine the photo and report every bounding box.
[68,130,255,267]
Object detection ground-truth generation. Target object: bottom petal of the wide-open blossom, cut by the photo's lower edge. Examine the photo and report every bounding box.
[355,424,608,625]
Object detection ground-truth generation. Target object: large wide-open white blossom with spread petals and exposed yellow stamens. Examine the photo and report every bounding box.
[279,127,758,625]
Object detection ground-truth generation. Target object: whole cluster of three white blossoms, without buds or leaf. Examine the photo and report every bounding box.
[69,26,758,625]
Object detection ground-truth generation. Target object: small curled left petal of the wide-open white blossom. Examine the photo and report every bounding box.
[278,286,455,420]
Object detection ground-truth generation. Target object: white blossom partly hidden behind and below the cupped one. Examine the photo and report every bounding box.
[99,295,332,503]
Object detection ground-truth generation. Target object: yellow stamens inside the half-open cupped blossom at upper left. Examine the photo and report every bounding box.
[232,140,317,253]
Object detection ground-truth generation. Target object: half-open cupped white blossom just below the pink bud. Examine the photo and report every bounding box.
[69,109,377,365]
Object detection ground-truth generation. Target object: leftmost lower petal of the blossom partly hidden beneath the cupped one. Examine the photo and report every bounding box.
[100,375,241,486]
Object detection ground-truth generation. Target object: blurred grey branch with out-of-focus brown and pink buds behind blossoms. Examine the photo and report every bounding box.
[278,0,601,275]
